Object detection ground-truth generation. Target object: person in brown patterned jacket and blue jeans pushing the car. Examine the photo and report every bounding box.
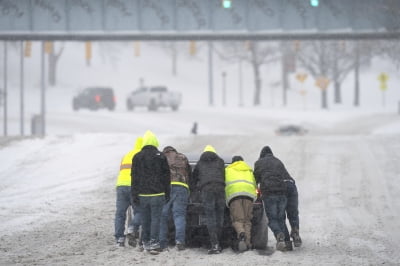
[160,146,192,250]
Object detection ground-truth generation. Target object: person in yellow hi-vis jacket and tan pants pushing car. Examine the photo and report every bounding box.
[225,156,257,252]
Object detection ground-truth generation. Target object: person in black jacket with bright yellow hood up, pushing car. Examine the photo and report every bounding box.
[132,130,171,254]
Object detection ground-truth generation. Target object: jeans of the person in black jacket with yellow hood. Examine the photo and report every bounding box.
[139,195,165,248]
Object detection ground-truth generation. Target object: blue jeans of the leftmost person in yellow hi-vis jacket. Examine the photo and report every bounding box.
[114,186,133,240]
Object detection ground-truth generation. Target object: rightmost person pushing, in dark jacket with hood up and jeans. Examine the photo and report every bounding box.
[254,146,290,251]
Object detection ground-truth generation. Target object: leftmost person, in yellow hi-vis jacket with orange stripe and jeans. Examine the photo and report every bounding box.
[114,137,143,247]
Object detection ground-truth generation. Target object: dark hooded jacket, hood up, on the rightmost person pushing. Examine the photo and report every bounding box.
[254,146,293,196]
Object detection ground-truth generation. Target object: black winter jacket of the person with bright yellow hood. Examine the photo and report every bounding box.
[131,145,171,204]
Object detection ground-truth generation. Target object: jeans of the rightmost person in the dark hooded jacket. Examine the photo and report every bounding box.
[263,195,289,240]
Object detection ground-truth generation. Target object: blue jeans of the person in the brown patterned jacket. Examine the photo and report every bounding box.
[160,185,189,248]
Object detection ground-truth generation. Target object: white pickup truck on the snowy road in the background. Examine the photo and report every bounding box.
[126,86,182,111]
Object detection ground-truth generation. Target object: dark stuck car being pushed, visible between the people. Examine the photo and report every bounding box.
[169,154,268,251]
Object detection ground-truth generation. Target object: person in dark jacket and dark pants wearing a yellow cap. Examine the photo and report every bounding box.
[191,145,225,254]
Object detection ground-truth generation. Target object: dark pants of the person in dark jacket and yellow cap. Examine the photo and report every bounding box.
[201,190,225,245]
